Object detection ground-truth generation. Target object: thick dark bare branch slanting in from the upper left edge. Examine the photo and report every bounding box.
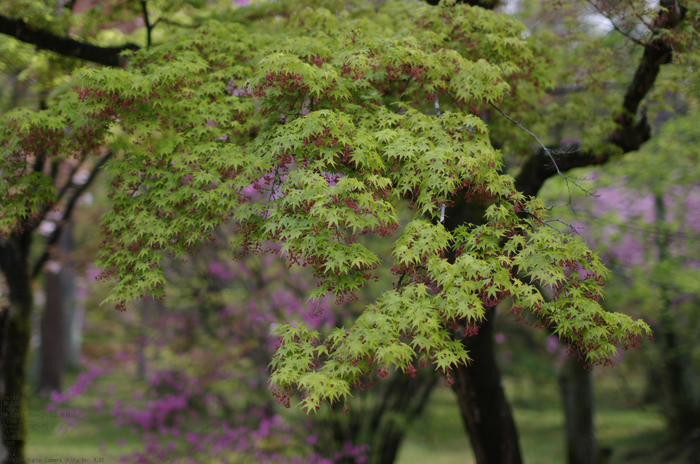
[0,15,139,68]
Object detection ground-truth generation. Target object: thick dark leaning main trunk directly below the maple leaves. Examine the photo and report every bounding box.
[452,308,522,464]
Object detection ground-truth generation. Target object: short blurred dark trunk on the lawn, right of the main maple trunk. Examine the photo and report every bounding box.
[559,355,598,464]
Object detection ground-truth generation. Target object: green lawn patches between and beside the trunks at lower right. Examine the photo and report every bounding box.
[397,379,665,464]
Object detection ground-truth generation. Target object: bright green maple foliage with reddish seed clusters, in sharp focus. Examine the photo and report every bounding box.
[3,2,648,410]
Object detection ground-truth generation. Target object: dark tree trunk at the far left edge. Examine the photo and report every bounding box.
[0,232,32,463]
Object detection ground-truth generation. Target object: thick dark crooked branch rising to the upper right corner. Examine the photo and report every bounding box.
[515,0,685,195]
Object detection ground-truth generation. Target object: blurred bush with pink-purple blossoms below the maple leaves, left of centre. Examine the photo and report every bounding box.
[46,248,368,464]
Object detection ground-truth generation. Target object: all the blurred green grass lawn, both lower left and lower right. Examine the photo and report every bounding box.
[28,368,664,464]
